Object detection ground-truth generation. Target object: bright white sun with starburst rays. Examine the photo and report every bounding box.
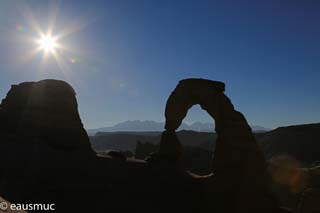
[19,0,88,70]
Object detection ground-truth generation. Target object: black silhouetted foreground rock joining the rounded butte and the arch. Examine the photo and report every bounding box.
[0,79,318,213]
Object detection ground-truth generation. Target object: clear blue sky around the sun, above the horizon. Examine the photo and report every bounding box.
[0,0,320,128]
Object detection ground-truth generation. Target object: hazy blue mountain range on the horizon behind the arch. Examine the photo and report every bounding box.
[87,120,270,135]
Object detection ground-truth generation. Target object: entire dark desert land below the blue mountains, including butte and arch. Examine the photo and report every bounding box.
[0,79,320,212]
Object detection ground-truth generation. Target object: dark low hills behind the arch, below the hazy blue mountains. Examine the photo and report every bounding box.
[90,123,320,165]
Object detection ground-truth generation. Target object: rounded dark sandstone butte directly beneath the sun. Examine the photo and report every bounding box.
[0,80,92,153]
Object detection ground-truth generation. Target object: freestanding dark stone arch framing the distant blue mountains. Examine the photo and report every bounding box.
[165,79,265,172]
